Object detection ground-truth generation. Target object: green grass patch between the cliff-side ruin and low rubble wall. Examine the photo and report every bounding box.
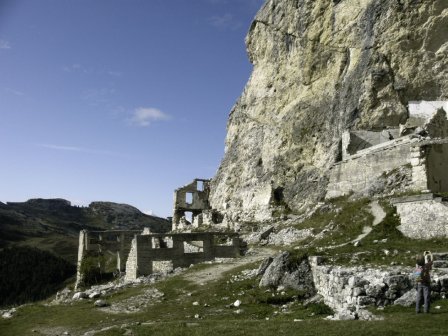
[294,197,448,267]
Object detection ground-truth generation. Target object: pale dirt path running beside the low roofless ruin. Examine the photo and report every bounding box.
[183,247,276,285]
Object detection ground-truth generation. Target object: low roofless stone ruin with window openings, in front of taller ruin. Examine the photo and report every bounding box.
[75,230,244,288]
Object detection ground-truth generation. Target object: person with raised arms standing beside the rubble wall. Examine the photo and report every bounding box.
[414,251,432,314]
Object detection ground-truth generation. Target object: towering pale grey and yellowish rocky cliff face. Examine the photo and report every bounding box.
[210,0,448,221]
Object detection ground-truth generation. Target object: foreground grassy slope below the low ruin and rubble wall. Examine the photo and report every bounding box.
[0,265,448,336]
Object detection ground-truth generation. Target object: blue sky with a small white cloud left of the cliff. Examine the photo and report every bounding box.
[0,0,264,217]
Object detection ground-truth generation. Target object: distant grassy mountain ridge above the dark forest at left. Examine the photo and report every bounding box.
[0,198,171,263]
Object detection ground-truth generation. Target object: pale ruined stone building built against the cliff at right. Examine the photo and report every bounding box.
[326,101,448,239]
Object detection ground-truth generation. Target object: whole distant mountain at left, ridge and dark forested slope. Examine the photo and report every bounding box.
[0,199,171,306]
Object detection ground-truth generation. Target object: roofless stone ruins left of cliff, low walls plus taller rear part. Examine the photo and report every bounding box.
[76,179,244,286]
